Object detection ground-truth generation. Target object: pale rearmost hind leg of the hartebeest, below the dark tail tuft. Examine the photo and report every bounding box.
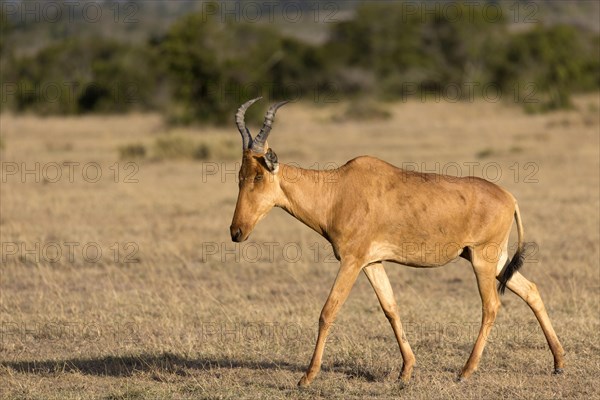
[506,272,565,374]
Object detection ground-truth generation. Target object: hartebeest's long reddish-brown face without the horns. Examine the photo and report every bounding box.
[229,149,279,242]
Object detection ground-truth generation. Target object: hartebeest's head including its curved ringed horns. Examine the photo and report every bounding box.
[230,97,287,242]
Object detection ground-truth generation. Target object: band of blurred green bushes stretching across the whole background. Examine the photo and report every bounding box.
[0,1,600,123]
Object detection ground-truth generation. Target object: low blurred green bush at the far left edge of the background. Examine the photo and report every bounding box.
[2,38,159,114]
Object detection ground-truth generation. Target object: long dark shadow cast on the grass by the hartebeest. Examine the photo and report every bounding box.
[0,353,377,381]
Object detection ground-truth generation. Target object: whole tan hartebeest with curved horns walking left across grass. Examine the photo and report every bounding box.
[230,97,564,386]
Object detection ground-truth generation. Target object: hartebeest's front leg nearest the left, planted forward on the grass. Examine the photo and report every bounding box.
[298,259,362,386]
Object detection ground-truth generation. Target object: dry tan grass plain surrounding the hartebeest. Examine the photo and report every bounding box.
[0,96,600,399]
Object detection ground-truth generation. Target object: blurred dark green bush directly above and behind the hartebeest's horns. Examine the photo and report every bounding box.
[159,5,328,123]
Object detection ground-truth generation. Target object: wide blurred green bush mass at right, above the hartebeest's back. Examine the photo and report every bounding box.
[325,3,600,111]
